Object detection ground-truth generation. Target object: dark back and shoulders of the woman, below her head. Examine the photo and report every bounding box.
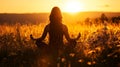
[46,23,67,49]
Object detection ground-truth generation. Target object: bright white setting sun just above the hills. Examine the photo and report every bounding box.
[64,0,83,13]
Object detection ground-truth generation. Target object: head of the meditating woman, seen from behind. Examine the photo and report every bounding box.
[49,7,62,23]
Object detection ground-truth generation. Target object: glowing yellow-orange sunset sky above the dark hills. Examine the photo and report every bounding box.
[0,0,120,13]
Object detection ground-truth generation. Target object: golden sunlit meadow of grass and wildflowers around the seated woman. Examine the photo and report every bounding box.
[0,12,120,67]
